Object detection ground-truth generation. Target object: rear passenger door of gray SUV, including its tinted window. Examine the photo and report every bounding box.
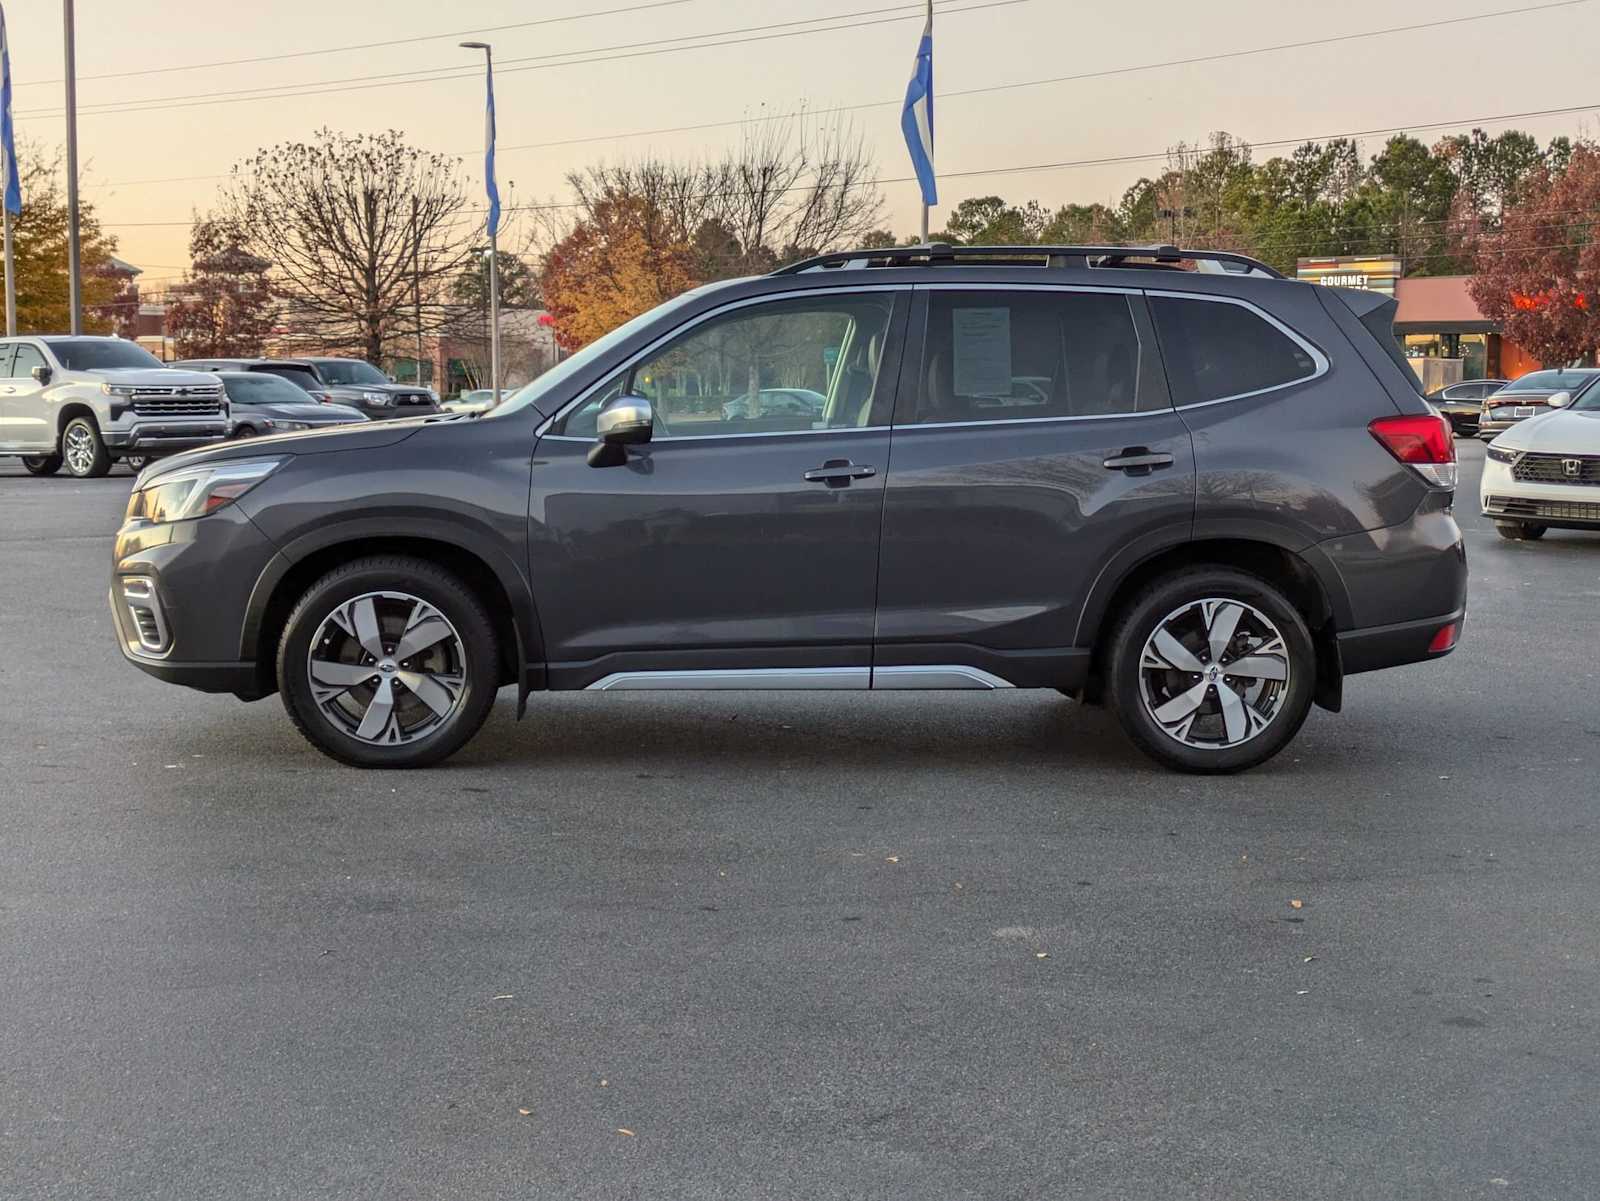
[874,285,1195,688]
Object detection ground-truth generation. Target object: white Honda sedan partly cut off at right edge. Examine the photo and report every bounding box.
[1480,384,1600,541]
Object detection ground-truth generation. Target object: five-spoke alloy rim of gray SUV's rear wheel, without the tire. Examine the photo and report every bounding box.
[1139,597,1290,750]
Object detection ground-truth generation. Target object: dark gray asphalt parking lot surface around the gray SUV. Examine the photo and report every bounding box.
[0,443,1600,1201]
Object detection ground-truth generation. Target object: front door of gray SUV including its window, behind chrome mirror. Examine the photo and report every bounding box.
[528,289,909,688]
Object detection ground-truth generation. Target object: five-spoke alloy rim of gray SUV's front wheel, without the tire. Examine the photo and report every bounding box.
[306,592,467,747]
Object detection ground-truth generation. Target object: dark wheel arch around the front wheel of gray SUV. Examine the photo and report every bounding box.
[249,531,542,696]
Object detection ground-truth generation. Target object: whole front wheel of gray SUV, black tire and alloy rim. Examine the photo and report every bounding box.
[277,555,499,768]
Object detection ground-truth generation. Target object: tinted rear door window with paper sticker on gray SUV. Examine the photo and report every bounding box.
[898,289,1141,424]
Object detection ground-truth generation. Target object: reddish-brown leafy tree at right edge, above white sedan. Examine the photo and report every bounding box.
[1467,142,1600,366]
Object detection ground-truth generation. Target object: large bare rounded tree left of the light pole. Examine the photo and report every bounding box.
[222,130,478,363]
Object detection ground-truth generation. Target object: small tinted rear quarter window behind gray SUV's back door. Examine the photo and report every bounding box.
[1150,296,1317,405]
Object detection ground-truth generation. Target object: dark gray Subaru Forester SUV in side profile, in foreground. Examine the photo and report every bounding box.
[110,245,1466,772]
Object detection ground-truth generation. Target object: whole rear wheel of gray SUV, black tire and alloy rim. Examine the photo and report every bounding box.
[1106,566,1317,774]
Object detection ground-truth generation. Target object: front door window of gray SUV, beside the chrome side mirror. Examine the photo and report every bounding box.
[555,293,894,440]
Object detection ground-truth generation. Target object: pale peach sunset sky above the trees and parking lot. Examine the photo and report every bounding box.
[5,0,1600,289]
